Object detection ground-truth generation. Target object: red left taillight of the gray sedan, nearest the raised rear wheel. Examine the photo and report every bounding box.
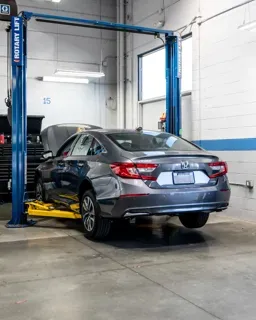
[110,162,158,181]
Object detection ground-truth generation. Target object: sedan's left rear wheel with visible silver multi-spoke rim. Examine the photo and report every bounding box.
[80,190,111,240]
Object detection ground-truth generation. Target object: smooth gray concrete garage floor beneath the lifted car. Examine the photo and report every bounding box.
[0,207,256,320]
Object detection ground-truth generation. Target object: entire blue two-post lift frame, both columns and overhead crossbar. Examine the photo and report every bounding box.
[7,12,181,228]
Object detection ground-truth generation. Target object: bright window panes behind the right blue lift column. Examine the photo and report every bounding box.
[139,34,192,101]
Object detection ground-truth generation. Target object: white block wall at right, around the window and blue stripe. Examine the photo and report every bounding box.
[126,0,256,220]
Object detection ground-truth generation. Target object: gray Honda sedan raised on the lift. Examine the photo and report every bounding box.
[36,129,230,239]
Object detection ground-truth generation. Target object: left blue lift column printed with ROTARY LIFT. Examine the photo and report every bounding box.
[7,17,30,227]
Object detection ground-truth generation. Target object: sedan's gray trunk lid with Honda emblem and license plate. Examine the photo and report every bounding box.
[129,150,219,189]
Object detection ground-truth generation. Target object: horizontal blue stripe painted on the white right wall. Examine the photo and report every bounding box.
[193,138,256,151]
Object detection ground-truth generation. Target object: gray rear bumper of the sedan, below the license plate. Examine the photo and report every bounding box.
[99,187,230,218]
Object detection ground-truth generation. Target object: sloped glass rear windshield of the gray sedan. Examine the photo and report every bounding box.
[107,131,200,152]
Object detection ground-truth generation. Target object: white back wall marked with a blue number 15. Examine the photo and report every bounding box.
[0,0,116,127]
